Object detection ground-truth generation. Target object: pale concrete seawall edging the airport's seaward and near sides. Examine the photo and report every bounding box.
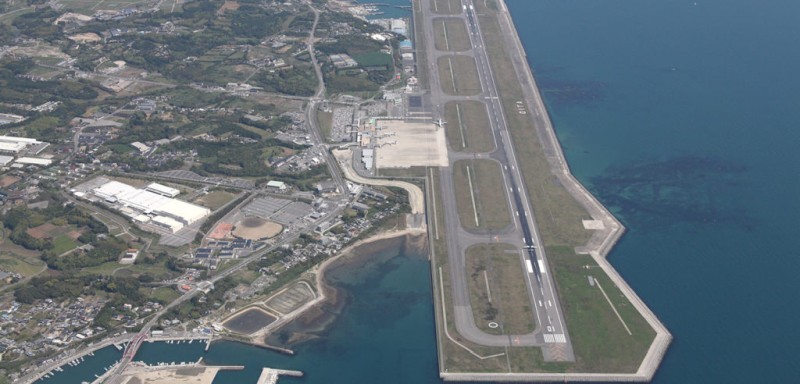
[432,0,672,381]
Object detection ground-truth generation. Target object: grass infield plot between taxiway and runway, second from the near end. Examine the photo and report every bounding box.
[453,160,511,230]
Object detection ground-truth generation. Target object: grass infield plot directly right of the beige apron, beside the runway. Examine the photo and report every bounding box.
[444,100,495,153]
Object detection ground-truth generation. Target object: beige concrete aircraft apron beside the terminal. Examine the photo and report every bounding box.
[375,120,447,168]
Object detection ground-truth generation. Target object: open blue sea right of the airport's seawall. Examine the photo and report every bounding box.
[508,0,800,383]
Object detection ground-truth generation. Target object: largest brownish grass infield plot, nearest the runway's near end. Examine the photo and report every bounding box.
[466,243,536,335]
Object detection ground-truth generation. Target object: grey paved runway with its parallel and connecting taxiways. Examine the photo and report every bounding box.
[420,0,574,361]
